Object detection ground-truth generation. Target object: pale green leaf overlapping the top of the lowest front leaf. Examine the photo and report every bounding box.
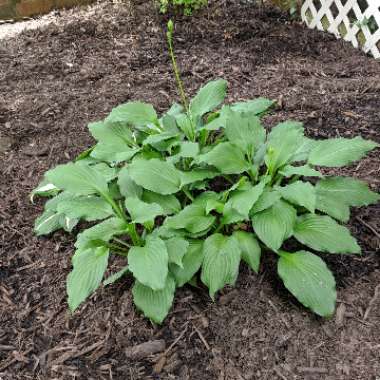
[128,236,169,290]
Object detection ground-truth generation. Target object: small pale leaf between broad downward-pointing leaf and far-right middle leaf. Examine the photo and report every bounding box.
[277,181,317,213]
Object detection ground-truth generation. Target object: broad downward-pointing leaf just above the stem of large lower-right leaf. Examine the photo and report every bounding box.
[252,200,297,252]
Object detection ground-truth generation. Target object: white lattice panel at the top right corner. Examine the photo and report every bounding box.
[301,0,380,58]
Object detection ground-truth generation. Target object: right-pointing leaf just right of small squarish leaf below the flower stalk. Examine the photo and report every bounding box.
[198,142,249,174]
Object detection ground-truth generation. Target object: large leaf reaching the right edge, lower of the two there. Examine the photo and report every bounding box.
[315,177,380,222]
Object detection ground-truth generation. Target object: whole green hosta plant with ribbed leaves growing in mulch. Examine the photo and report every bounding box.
[33,24,380,323]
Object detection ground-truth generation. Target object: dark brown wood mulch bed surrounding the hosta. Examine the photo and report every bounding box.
[0,1,380,380]
